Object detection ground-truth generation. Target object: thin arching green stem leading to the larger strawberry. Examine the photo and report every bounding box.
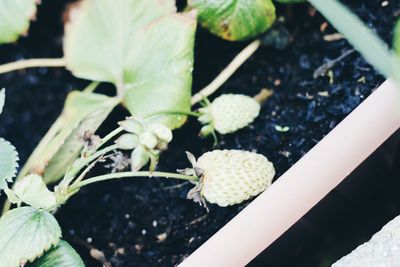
[69,171,198,191]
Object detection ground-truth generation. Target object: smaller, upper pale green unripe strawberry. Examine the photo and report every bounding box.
[199,94,260,135]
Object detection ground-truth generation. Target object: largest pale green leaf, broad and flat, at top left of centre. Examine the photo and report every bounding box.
[64,0,196,128]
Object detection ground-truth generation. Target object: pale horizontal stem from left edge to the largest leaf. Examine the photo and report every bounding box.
[0,58,65,74]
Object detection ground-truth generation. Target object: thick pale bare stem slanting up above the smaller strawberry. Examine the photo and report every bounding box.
[192,40,261,105]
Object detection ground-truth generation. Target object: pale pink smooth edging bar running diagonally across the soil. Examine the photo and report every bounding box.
[179,80,400,267]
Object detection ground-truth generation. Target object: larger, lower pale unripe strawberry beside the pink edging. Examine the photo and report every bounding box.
[190,150,275,207]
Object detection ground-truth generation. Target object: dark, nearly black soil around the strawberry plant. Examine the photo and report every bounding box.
[0,0,400,266]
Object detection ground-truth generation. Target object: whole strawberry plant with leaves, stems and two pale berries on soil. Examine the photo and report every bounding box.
[0,0,400,267]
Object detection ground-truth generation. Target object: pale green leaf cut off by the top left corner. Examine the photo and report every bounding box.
[0,0,37,43]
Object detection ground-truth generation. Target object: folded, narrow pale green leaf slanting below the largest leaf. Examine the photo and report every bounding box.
[18,91,120,184]
